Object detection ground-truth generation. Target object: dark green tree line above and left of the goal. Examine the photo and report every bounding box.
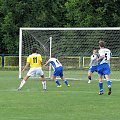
[0,0,120,54]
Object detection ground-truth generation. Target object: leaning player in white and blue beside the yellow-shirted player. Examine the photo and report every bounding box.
[45,55,70,87]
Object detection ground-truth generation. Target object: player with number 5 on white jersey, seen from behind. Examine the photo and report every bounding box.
[97,41,111,95]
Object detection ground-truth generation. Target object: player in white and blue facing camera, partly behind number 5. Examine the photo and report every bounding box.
[88,48,98,83]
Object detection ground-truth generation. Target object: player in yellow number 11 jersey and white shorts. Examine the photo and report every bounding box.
[18,48,46,90]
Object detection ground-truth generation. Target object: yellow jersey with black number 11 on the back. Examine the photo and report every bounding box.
[27,53,42,68]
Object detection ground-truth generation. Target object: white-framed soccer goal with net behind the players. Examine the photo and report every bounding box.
[19,28,120,80]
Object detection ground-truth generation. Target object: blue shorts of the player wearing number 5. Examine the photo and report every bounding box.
[97,63,111,75]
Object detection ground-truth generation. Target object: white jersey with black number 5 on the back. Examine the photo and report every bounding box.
[98,48,112,64]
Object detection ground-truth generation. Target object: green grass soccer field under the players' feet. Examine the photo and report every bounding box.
[0,71,120,120]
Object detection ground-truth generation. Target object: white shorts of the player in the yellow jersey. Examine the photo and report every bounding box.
[27,67,44,76]
